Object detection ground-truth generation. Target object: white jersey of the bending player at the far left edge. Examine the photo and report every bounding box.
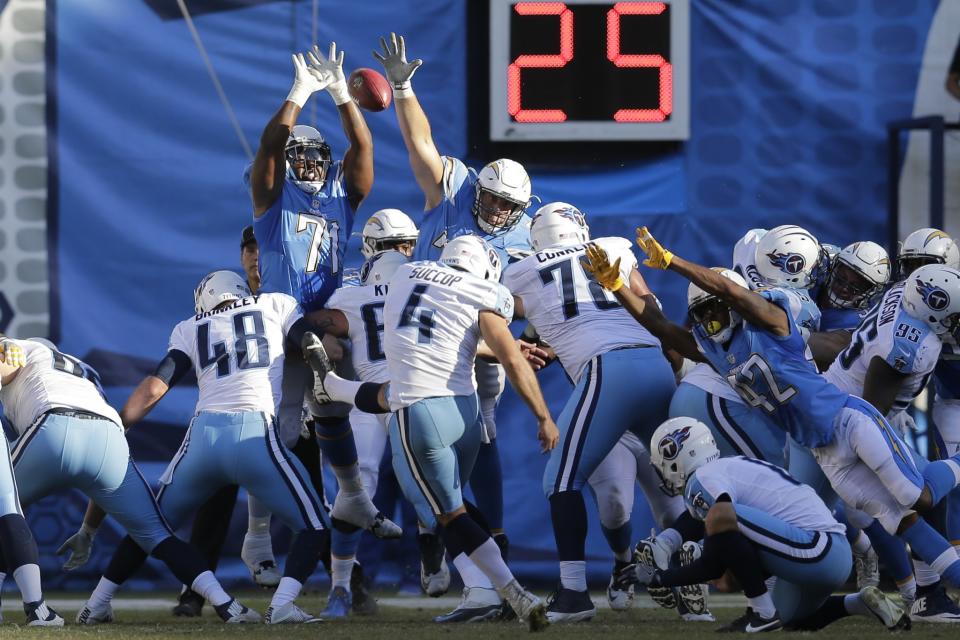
[0,338,120,434]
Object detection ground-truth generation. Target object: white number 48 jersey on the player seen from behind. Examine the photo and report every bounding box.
[169,293,301,416]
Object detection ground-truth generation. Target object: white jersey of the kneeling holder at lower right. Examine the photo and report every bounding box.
[683,456,846,535]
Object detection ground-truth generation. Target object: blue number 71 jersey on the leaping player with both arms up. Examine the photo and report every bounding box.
[253,162,354,312]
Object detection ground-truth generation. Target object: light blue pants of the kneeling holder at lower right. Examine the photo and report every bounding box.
[734,504,853,624]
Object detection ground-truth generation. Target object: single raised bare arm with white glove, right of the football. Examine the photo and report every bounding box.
[373,33,443,209]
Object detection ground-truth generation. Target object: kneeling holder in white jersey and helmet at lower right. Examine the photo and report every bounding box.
[636,418,910,633]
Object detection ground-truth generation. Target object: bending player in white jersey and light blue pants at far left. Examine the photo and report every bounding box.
[0,341,260,624]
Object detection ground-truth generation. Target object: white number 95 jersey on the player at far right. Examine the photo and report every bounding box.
[823,282,942,416]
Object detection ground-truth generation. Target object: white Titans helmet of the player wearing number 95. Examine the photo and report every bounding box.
[903,264,960,341]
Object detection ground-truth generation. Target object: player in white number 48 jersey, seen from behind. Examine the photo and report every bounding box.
[74,271,334,624]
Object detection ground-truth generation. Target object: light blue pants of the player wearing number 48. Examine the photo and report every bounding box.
[157,411,326,532]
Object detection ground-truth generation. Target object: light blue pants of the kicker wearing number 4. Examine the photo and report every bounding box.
[390,394,482,524]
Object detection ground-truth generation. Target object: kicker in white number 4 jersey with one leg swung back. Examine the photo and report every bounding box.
[304,236,558,631]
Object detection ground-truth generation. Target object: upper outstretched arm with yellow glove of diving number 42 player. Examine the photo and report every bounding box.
[637,227,790,336]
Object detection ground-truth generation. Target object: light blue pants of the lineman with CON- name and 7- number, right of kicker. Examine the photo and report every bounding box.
[543,347,676,498]
